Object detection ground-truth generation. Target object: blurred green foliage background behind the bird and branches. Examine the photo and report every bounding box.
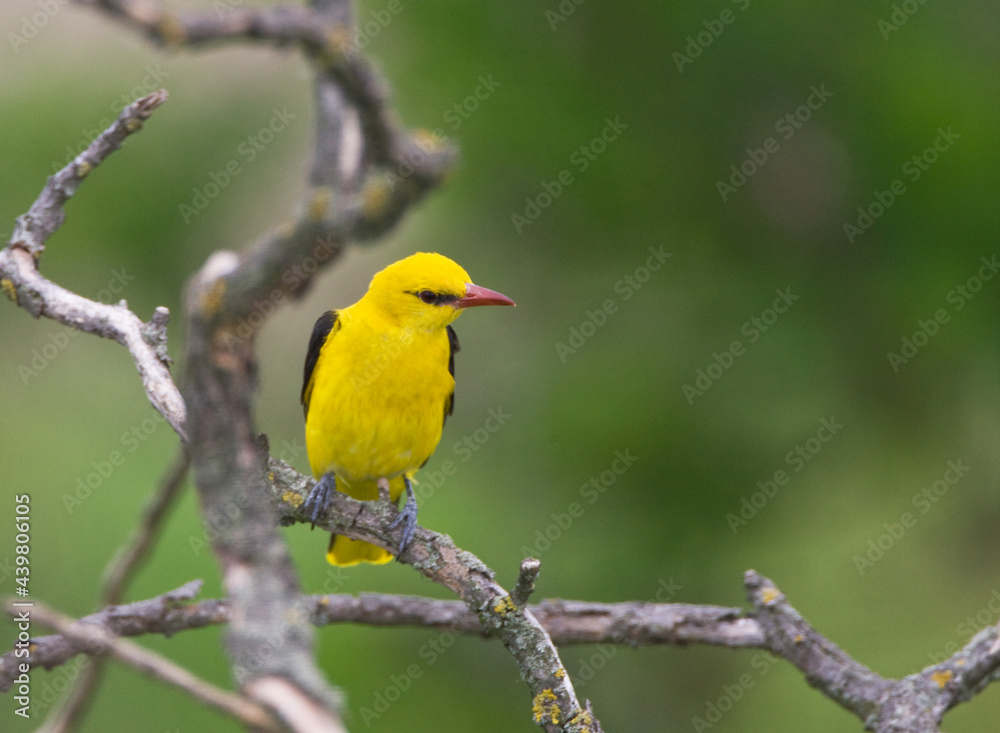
[0,0,1000,733]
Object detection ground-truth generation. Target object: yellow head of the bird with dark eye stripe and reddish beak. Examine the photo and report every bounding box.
[364,252,514,331]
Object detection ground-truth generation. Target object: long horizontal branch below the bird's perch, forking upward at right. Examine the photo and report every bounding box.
[11,564,1000,733]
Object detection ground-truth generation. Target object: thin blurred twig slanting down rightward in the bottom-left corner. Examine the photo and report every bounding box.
[8,602,277,730]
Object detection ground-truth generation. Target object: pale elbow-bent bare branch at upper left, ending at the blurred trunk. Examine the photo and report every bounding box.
[0,90,186,440]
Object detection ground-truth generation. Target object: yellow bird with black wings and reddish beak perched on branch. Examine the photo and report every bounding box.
[302,252,514,565]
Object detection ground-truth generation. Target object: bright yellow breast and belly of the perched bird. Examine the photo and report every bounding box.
[306,307,455,488]
